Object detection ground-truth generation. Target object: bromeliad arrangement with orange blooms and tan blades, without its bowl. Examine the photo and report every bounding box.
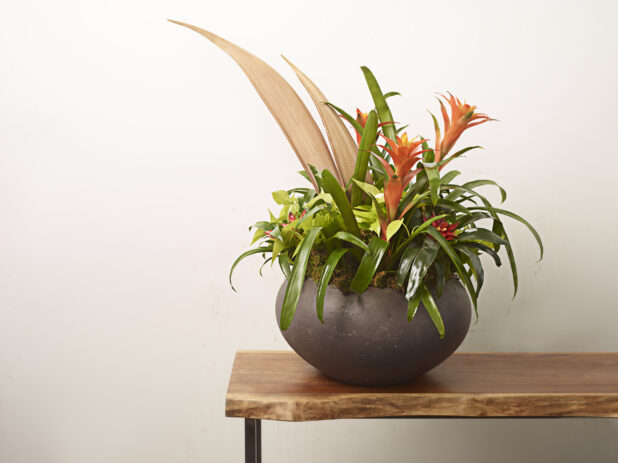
[167,23,543,336]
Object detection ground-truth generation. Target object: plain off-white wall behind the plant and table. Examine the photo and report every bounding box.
[0,0,618,463]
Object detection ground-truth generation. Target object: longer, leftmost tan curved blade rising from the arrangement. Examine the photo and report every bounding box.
[169,19,337,191]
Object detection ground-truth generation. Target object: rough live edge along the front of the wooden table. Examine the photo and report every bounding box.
[225,392,618,421]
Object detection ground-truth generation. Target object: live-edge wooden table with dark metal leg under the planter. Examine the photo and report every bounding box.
[225,351,618,463]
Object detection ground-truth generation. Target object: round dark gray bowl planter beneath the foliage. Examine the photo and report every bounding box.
[276,278,472,386]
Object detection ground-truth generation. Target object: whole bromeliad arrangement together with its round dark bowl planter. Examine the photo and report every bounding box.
[174,21,543,385]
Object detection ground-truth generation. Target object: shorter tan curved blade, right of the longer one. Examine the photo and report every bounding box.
[282,56,358,185]
